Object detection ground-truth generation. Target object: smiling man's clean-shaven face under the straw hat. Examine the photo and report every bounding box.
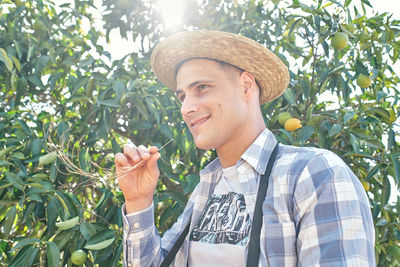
[176,59,247,151]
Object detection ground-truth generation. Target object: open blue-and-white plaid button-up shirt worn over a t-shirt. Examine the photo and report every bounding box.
[123,129,375,267]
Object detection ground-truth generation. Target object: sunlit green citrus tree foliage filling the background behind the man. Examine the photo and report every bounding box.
[0,0,400,266]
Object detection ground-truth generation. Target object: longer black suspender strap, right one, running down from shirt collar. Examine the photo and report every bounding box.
[246,143,279,267]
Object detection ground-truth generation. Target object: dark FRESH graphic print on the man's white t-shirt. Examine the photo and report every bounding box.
[190,192,251,246]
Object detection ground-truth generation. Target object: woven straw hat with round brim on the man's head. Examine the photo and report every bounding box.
[151,30,289,104]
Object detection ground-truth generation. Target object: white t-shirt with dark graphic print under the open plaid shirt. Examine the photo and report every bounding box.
[189,166,251,267]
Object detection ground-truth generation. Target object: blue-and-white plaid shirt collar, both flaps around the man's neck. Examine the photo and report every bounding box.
[200,128,277,176]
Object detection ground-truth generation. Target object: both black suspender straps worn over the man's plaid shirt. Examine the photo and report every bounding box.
[160,143,279,267]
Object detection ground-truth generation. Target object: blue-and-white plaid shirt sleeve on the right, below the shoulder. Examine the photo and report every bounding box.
[294,152,375,267]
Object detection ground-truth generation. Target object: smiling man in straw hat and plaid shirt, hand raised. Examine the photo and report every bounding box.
[115,31,375,266]
